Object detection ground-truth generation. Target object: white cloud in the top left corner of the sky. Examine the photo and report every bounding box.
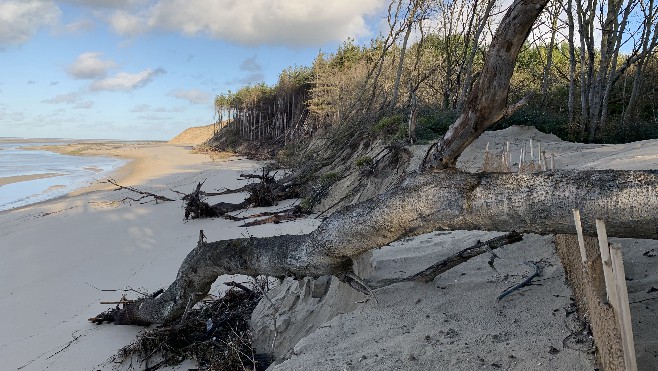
[0,0,62,45]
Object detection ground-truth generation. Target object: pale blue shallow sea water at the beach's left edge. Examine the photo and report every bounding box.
[0,138,127,211]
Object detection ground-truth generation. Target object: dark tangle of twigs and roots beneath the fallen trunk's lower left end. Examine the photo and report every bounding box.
[104,282,272,370]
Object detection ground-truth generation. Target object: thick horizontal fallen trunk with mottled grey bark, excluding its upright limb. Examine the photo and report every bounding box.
[116,170,658,324]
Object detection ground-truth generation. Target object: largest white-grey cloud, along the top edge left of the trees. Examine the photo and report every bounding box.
[110,0,385,45]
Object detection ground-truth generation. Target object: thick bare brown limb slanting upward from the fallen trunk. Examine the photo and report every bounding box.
[423,0,548,168]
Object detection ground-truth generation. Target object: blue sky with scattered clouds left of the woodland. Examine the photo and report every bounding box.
[0,0,388,140]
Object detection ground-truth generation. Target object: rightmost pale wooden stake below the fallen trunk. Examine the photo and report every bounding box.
[610,244,637,371]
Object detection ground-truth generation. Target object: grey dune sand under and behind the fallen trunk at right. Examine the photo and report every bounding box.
[259,127,658,371]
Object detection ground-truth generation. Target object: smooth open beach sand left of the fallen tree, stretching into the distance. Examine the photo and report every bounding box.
[0,144,316,370]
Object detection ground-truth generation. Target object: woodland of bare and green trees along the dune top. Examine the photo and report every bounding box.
[215,0,658,151]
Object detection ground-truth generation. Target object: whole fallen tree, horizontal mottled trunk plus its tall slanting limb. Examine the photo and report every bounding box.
[105,0,658,324]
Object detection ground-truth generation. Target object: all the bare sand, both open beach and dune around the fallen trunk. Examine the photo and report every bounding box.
[0,128,658,370]
